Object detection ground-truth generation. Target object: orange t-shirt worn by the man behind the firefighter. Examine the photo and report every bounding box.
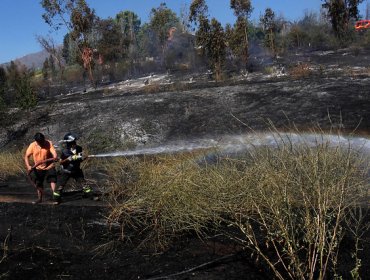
[26,140,57,170]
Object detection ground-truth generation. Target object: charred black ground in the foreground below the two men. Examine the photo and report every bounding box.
[0,200,370,280]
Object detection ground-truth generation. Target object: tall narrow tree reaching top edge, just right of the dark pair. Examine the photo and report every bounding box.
[230,0,253,69]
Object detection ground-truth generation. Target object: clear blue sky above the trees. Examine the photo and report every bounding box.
[0,0,366,64]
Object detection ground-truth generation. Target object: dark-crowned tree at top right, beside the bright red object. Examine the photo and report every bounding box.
[322,0,364,38]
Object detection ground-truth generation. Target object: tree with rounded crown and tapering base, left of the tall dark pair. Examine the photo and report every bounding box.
[150,3,180,65]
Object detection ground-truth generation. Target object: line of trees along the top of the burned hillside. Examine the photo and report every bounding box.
[0,0,370,110]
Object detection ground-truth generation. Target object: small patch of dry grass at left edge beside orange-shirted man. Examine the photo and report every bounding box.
[0,151,25,181]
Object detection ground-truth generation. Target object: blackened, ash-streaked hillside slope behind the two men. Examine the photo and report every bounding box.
[0,48,370,153]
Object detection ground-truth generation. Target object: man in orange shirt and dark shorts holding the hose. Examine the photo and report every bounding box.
[24,132,60,204]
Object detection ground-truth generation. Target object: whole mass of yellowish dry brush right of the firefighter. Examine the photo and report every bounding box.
[102,130,369,279]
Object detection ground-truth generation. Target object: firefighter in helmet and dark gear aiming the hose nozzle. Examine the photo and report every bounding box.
[58,133,92,202]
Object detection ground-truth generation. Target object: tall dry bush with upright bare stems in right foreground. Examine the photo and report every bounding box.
[228,134,369,279]
